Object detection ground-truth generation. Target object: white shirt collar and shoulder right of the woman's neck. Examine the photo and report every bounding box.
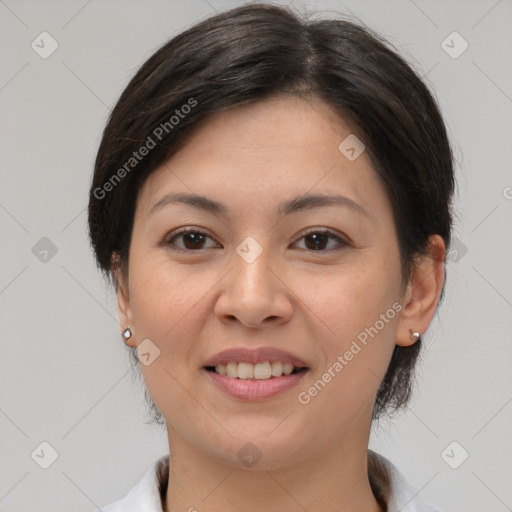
[368,450,442,512]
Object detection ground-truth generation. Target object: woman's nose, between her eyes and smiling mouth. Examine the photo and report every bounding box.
[214,250,293,328]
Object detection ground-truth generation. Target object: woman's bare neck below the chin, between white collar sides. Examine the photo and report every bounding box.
[164,426,383,512]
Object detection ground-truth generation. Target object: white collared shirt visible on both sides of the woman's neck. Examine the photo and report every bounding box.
[101,454,441,512]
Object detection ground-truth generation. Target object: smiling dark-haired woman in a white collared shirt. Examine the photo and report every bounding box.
[89,4,454,512]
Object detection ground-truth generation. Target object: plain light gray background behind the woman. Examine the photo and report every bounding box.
[0,0,512,512]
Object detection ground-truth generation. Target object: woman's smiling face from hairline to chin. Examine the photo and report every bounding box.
[118,96,418,468]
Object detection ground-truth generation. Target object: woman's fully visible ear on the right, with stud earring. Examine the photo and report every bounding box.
[396,235,446,347]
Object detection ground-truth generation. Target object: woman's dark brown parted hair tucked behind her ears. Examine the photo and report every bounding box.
[89,4,454,421]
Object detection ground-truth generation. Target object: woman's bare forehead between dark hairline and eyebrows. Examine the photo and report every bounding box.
[138,95,387,219]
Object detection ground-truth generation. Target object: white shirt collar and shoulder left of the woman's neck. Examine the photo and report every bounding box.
[101,455,169,512]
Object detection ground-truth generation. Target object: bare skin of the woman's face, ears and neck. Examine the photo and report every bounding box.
[117,96,445,512]
